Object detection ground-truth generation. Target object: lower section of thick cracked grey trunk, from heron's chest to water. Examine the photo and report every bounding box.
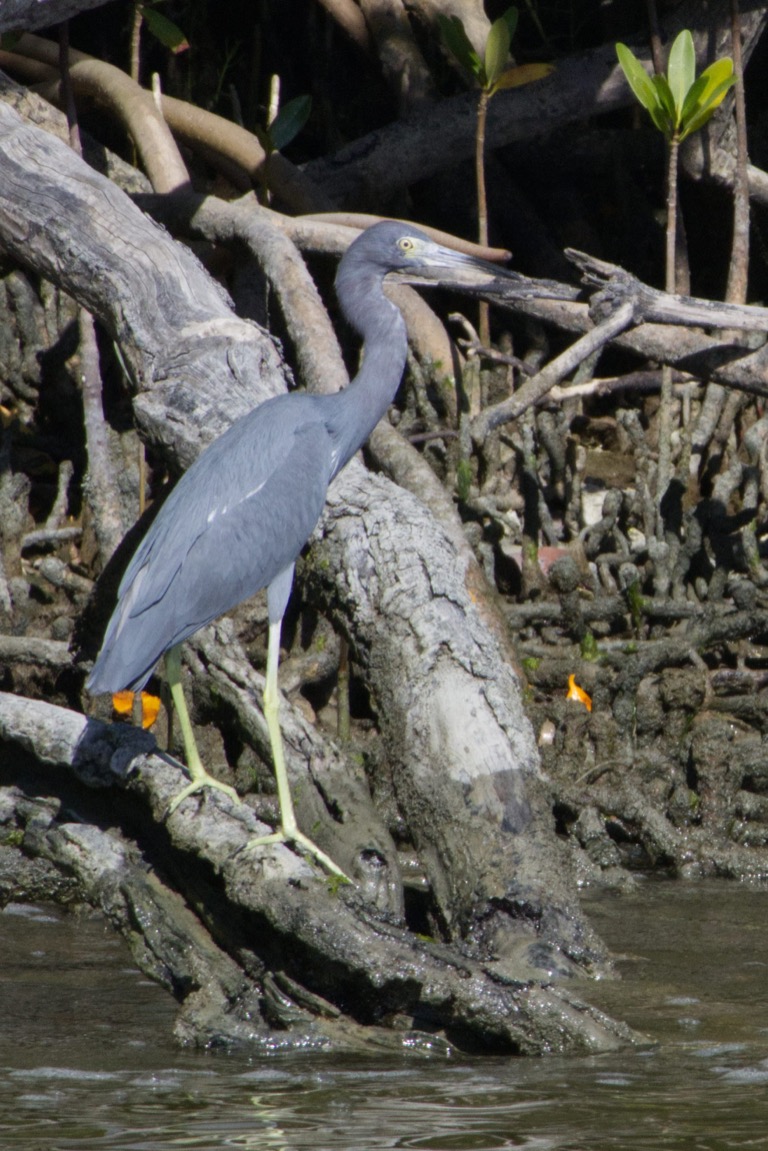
[303,470,603,970]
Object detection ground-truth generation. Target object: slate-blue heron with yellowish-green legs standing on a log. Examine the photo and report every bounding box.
[88,221,511,875]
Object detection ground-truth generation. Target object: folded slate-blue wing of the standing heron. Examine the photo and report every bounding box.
[89,402,333,692]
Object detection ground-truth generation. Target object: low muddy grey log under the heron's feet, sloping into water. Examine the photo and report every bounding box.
[0,693,636,1054]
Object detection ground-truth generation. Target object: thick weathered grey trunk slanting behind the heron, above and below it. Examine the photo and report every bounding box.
[0,106,626,1054]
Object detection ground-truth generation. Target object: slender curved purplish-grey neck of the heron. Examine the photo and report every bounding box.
[330,273,408,472]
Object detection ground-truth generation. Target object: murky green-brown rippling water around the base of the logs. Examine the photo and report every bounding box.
[0,882,768,1151]
